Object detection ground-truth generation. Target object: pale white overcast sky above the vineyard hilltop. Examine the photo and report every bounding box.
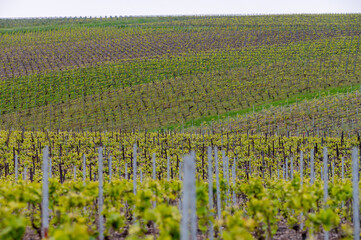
[0,0,361,18]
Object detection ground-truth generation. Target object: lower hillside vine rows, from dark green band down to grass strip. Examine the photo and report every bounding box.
[1,35,361,129]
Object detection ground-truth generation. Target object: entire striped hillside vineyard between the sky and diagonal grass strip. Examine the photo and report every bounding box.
[0,15,361,132]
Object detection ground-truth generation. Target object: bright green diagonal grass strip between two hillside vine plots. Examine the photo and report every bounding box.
[159,84,361,131]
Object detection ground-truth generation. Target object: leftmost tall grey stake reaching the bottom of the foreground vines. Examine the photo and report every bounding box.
[41,146,49,238]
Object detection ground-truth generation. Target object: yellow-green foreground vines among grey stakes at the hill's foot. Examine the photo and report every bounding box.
[0,131,361,239]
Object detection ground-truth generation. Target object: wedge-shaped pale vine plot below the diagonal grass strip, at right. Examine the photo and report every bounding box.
[190,87,361,137]
